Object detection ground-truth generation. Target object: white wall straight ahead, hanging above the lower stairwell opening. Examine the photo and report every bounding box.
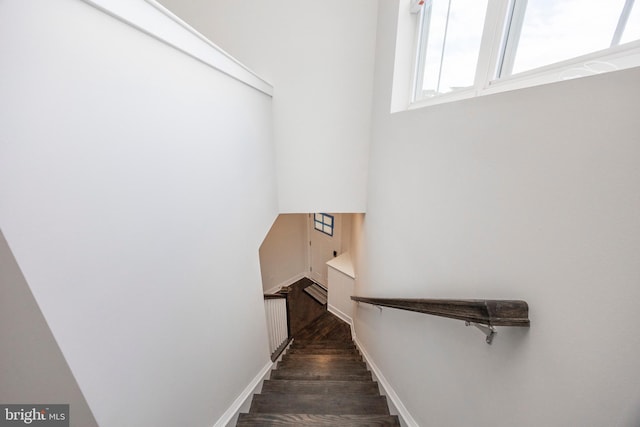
[161,0,376,213]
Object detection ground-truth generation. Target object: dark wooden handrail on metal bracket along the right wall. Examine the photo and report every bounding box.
[351,296,530,327]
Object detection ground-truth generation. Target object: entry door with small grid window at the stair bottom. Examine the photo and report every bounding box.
[308,213,342,287]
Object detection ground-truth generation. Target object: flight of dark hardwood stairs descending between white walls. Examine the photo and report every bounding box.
[237,312,400,427]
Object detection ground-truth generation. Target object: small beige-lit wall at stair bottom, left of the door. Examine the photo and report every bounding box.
[260,214,309,292]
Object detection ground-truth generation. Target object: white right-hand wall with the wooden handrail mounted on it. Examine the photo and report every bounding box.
[353,1,640,427]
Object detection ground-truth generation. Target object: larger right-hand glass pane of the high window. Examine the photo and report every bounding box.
[512,0,625,74]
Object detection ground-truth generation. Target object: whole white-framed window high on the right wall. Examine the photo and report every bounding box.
[414,0,640,103]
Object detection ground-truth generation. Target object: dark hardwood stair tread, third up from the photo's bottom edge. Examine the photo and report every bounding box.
[261,380,380,395]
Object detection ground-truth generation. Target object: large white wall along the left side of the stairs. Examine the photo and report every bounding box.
[0,0,277,427]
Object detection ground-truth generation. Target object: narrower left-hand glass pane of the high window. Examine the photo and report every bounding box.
[422,0,487,96]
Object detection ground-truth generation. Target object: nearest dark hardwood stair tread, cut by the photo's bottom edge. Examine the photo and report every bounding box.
[237,414,400,427]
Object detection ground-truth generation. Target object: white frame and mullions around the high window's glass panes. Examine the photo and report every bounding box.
[409,0,640,110]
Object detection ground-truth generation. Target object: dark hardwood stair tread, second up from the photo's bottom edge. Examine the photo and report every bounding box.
[249,393,389,415]
